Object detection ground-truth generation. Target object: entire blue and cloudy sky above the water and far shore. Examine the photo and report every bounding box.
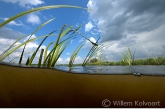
[0,0,165,64]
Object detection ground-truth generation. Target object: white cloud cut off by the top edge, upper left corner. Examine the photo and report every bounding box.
[1,0,44,7]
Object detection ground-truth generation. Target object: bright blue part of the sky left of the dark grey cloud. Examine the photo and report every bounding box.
[0,0,97,62]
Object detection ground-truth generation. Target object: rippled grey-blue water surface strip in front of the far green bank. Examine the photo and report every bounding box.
[55,65,165,76]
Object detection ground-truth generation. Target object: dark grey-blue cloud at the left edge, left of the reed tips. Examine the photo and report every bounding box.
[0,28,23,39]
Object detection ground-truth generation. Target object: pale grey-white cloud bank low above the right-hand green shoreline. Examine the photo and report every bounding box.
[102,25,165,61]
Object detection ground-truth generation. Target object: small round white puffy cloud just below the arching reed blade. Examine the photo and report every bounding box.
[27,13,41,25]
